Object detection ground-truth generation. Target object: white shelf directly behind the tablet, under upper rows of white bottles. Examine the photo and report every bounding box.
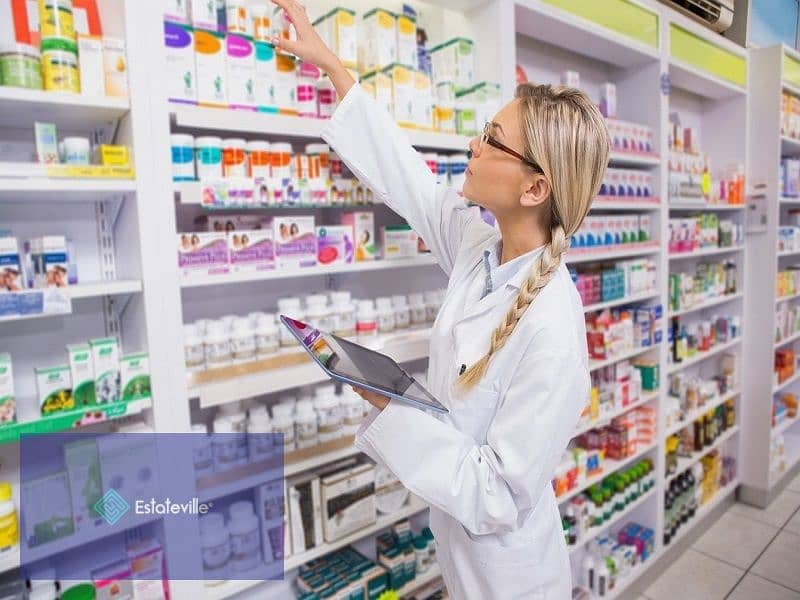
[188,329,430,408]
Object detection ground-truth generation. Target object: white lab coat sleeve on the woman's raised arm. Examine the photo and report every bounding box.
[322,84,480,274]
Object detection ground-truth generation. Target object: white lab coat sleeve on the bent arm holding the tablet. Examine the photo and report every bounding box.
[356,351,589,535]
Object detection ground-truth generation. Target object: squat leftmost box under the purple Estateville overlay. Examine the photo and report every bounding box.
[21,471,75,548]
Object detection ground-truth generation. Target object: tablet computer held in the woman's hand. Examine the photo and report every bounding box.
[280,315,448,413]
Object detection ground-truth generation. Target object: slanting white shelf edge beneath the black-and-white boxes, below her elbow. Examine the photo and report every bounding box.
[206,495,428,600]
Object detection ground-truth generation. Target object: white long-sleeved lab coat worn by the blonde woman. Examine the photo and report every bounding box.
[323,85,590,600]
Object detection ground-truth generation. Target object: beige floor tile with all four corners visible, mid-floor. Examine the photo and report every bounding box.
[694,512,779,570]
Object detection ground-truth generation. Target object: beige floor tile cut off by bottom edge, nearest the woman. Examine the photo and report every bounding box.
[645,550,744,600]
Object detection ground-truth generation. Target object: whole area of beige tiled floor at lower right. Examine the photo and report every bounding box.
[640,476,800,600]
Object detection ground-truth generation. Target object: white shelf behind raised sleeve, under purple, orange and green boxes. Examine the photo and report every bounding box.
[170,105,471,152]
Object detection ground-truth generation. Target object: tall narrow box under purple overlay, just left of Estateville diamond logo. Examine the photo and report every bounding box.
[64,437,104,531]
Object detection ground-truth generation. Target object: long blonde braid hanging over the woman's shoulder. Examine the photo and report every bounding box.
[458,225,569,390]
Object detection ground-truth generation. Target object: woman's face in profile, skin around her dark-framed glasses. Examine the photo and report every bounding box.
[462,100,533,213]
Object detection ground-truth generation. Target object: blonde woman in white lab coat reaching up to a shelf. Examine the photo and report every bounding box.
[273,0,609,600]
